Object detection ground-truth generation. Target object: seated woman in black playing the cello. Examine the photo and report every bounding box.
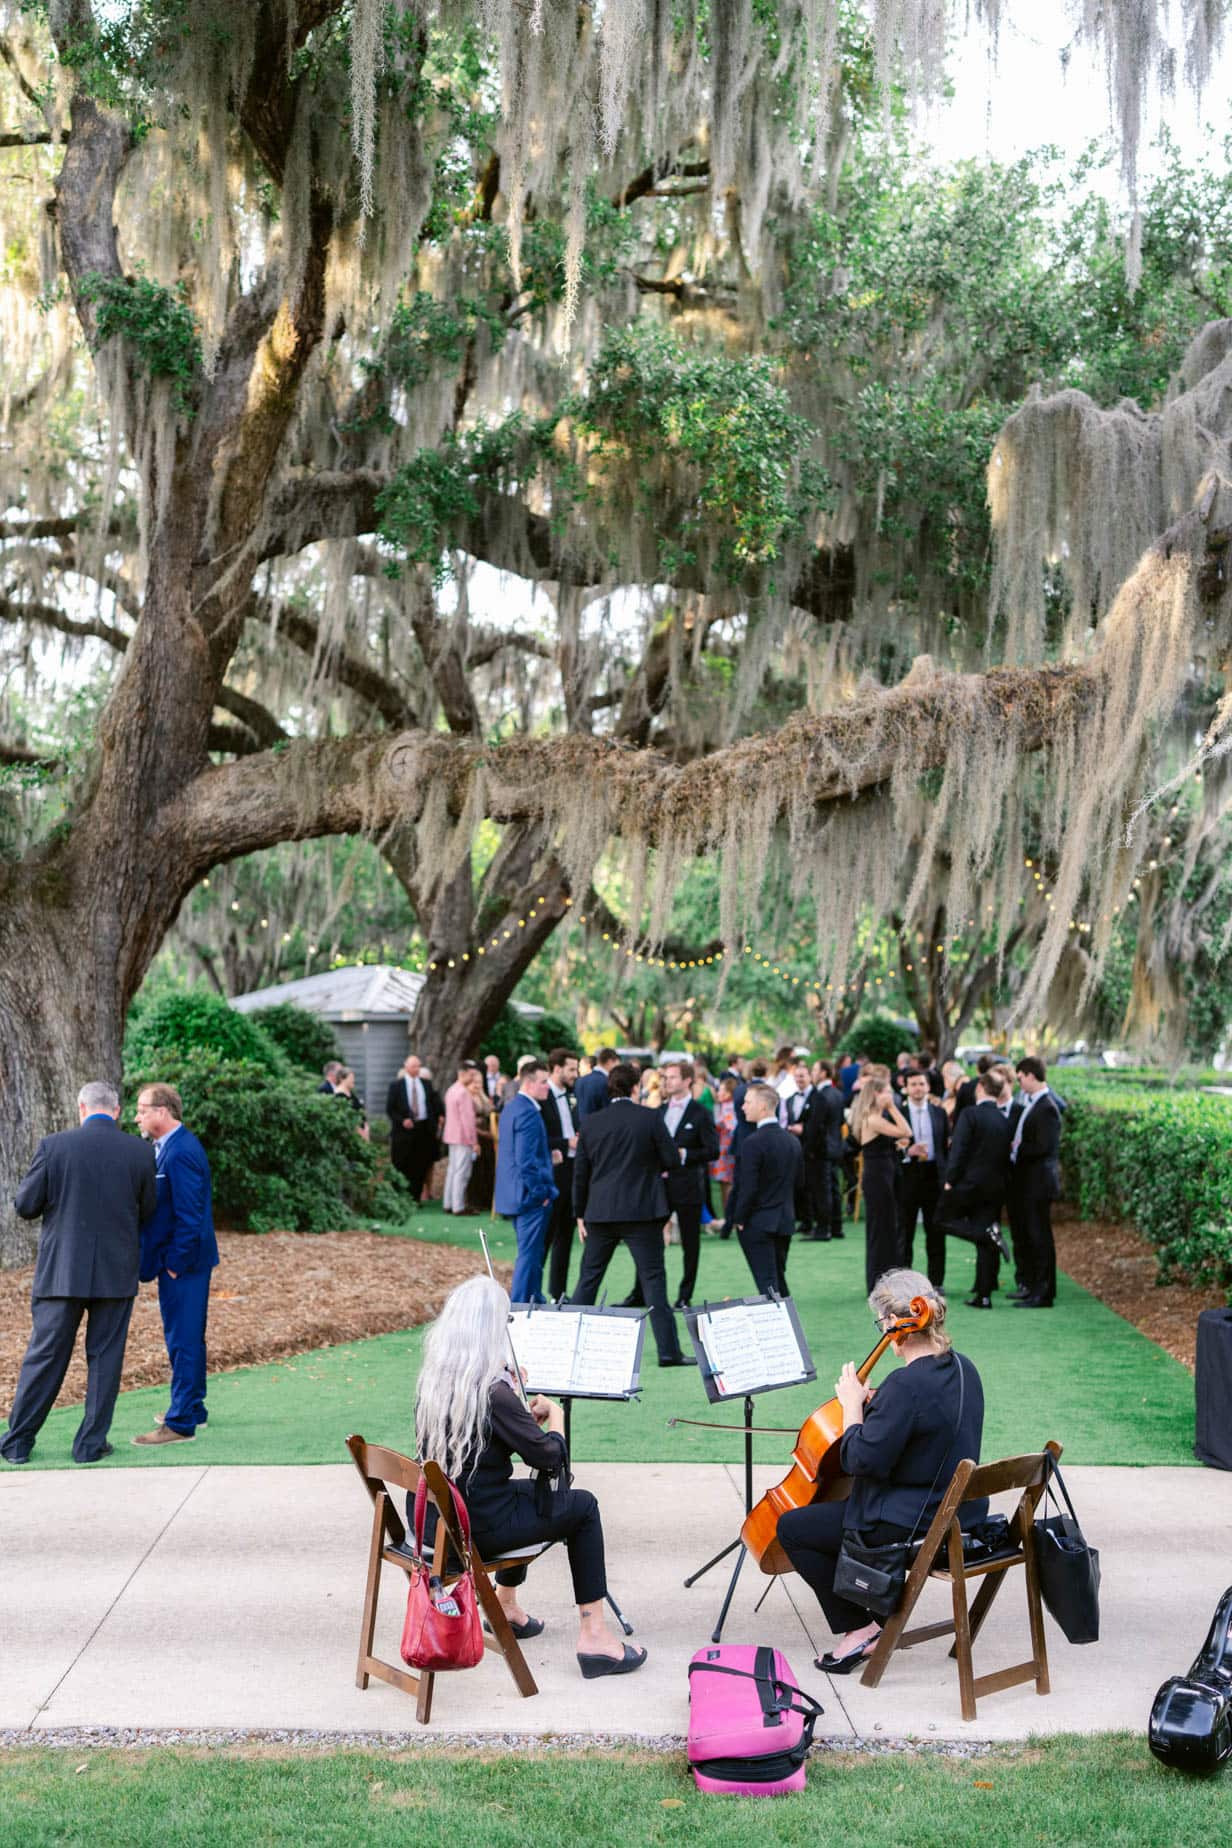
[778,1270,988,1674]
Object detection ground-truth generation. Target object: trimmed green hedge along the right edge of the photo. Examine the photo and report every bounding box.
[1049,1068,1232,1290]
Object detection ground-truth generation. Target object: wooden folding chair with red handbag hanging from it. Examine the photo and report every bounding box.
[347,1438,550,1726]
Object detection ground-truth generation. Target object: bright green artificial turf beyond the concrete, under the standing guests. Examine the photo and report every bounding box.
[14,1207,1193,1467]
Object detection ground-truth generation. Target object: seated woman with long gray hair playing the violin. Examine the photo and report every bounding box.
[416,1277,646,1682]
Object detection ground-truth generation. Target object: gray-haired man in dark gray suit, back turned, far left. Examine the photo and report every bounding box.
[0,1085,157,1464]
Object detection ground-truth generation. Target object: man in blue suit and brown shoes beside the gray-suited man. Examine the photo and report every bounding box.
[133,1085,218,1445]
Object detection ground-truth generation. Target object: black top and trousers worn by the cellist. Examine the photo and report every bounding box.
[778,1349,988,1635]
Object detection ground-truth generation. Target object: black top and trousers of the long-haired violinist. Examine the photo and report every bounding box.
[406,1380,608,1604]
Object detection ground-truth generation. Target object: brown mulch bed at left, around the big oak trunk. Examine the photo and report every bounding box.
[0,1233,512,1417]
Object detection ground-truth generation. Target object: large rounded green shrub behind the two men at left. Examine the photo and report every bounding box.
[127,1049,406,1233]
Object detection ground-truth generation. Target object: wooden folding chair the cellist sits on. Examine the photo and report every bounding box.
[861,1443,1060,1720]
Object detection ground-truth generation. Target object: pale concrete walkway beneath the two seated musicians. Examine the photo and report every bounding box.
[0,1441,1232,1743]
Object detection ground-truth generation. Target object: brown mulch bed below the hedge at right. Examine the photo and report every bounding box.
[1053,1207,1226,1373]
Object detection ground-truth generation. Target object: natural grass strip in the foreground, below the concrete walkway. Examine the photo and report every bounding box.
[0,1735,1230,1848]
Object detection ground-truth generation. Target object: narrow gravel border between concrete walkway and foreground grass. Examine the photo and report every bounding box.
[0,1726,1004,1757]
